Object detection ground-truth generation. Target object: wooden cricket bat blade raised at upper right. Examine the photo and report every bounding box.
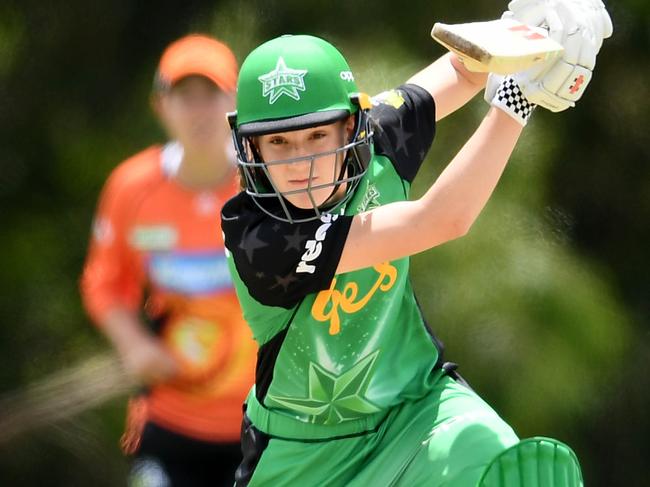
[431,19,564,74]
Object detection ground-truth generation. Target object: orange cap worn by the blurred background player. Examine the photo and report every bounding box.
[156,34,238,92]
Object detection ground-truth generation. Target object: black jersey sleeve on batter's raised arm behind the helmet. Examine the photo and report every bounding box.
[370,84,436,182]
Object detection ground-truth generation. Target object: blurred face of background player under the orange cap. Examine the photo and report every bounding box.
[158,76,233,151]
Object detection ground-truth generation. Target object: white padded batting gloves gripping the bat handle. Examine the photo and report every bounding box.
[485,0,613,112]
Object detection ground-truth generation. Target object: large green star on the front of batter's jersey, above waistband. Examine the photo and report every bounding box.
[267,350,380,424]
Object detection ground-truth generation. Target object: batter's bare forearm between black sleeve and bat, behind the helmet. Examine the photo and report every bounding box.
[408,53,487,120]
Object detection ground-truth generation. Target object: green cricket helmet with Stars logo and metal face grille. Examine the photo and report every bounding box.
[228,35,372,222]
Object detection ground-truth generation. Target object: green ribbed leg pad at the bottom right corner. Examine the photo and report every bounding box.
[477,437,583,487]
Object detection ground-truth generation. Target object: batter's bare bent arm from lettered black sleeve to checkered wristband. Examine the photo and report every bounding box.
[336,108,522,273]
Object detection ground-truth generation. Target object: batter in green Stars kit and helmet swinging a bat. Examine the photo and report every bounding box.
[222,0,611,487]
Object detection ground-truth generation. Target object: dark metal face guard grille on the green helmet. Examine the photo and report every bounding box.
[228,95,373,223]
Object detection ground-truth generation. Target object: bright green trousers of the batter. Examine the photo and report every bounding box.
[248,376,519,487]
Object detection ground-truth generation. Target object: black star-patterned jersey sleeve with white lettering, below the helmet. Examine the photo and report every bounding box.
[221,193,352,308]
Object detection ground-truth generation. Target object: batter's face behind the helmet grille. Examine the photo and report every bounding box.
[256,117,354,209]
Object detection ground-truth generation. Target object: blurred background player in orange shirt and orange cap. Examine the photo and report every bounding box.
[82,35,256,487]
